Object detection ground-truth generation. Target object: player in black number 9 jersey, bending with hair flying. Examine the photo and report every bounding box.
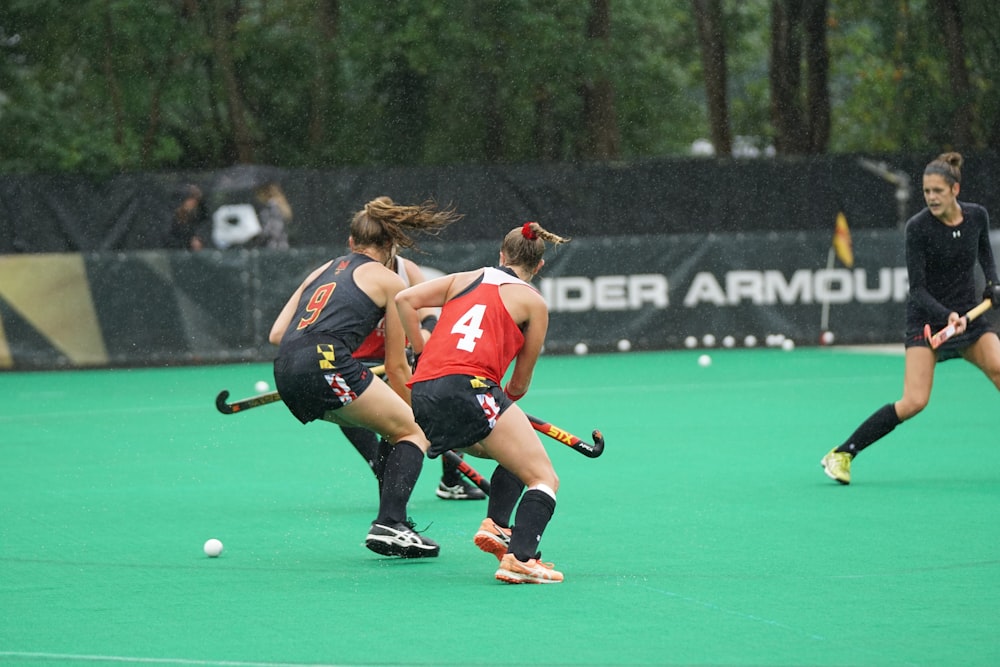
[269,197,460,558]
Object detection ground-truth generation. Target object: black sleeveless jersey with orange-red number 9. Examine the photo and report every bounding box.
[279,253,385,352]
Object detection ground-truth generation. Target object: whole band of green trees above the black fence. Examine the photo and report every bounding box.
[0,0,1000,175]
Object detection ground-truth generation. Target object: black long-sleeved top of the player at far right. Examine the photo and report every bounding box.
[906,202,997,330]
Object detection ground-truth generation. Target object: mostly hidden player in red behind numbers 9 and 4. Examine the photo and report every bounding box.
[340,254,486,500]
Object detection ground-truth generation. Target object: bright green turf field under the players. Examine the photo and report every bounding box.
[0,348,1000,667]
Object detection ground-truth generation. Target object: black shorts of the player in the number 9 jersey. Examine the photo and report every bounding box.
[274,341,375,424]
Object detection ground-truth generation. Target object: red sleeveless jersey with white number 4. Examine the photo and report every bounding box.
[409,267,535,387]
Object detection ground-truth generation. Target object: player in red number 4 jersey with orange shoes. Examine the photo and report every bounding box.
[396,222,568,584]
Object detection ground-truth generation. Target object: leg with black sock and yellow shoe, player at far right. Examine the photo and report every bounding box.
[821,345,937,484]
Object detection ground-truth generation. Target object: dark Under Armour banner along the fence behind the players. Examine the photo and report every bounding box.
[0,228,1000,369]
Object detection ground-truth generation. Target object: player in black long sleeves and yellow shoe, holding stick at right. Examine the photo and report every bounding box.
[821,153,1000,484]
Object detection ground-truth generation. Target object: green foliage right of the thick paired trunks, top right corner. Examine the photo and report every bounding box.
[829,0,1000,152]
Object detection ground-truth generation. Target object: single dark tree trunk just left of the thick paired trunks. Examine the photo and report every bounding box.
[691,0,733,156]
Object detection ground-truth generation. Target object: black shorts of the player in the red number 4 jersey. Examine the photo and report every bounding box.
[411,375,513,458]
